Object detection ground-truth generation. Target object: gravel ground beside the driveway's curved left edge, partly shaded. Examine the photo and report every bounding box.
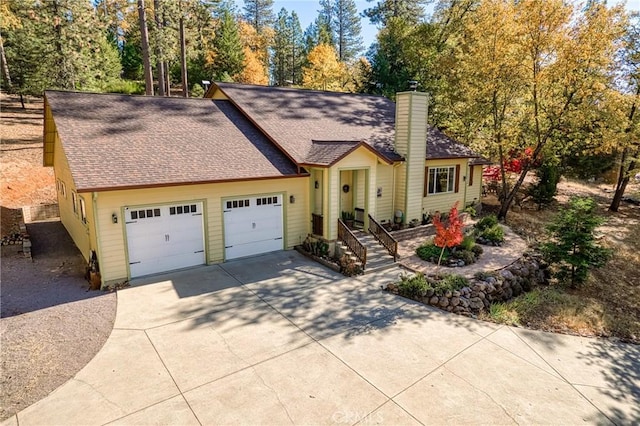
[0,221,116,421]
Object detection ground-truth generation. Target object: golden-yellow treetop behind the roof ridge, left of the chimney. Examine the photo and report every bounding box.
[302,44,347,91]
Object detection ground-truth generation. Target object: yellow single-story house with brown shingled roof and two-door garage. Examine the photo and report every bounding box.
[44,83,482,285]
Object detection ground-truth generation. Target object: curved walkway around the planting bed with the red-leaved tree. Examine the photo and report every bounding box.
[398,225,527,278]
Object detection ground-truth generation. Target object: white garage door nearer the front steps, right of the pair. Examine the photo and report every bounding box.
[223,194,283,260]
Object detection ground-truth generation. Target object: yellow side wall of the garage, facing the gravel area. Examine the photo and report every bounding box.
[53,134,94,260]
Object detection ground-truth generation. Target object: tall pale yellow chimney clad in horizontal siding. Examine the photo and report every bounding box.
[394,92,429,223]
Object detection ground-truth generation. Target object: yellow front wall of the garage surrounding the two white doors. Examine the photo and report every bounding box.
[96,178,311,282]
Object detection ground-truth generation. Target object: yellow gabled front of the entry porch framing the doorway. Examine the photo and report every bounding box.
[325,147,378,240]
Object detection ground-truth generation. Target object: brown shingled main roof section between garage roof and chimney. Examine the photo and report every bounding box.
[215,82,401,164]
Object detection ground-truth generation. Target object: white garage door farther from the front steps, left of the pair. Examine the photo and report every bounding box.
[125,203,205,277]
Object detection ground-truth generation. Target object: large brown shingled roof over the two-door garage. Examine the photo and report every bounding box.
[45,91,299,192]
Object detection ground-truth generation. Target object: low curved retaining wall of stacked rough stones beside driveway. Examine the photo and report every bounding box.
[387,254,549,316]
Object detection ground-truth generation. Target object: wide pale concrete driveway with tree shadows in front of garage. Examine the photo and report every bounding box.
[3,252,640,426]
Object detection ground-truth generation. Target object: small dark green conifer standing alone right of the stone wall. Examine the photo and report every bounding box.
[541,197,611,287]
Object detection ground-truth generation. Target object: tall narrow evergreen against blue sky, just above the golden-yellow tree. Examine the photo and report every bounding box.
[333,0,362,62]
